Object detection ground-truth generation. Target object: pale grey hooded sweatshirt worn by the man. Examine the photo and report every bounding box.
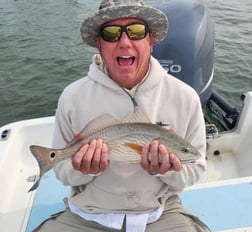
[53,54,206,213]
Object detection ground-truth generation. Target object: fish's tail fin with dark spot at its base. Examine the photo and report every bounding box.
[28,145,55,192]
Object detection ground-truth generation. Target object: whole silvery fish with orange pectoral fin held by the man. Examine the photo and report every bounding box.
[29,107,200,191]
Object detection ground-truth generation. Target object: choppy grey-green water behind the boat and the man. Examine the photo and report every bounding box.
[0,0,252,126]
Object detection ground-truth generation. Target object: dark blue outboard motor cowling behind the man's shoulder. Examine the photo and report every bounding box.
[153,0,214,105]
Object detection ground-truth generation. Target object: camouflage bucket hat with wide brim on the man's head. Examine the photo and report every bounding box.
[81,0,168,47]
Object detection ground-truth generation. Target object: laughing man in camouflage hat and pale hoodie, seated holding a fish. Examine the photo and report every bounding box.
[35,0,209,232]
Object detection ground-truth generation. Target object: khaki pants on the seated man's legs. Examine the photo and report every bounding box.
[33,196,210,232]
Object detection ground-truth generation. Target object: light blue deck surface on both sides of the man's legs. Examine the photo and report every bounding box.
[22,171,252,232]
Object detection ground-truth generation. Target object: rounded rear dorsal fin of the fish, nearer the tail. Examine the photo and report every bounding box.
[80,114,120,137]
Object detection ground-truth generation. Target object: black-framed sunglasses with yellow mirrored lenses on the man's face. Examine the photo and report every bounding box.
[101,24,148,42]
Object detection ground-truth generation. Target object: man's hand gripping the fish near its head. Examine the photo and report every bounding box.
[140,140,182,175]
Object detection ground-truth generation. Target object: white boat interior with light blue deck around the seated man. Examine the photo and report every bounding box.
[0,92,252,232]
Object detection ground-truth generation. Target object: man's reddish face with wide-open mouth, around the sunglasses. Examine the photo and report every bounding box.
[96,18,153,89]
